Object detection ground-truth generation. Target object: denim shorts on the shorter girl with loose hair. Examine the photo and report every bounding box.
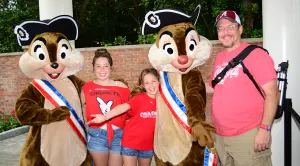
[121,146,153,158]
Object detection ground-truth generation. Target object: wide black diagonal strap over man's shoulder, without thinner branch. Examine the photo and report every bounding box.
[211,45,268,88]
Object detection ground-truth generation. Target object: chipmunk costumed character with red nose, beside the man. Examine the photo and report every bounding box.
[142,5,215,166]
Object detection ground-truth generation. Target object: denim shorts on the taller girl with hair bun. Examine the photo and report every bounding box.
[87,127,123,154]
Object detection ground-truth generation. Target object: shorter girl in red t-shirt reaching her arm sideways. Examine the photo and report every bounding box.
[89,68,159,166]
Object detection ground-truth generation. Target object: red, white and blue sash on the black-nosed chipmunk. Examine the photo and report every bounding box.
[31,79,86,145]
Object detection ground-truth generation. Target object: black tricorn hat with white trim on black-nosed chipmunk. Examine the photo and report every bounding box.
[14,15,78,46]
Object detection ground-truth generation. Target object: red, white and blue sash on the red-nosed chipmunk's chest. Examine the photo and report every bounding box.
[159,71,192,134]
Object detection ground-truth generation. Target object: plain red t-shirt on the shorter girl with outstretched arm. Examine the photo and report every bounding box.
[122,93,156,150]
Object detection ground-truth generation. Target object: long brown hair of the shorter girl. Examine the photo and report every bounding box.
[129,68,159,98]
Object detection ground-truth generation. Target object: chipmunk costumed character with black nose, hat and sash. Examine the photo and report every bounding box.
[14,15,91,166]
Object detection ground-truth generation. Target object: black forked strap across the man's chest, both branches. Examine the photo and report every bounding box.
[211,45,269,98]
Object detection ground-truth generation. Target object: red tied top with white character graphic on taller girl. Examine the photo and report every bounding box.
[82,81,130,128]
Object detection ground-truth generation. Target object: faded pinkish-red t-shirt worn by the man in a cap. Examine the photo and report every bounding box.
[210,42,277,136]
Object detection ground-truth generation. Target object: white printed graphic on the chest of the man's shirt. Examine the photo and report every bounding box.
[214,62,242,84]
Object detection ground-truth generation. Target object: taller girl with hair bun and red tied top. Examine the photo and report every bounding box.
[82,49,130,166]
